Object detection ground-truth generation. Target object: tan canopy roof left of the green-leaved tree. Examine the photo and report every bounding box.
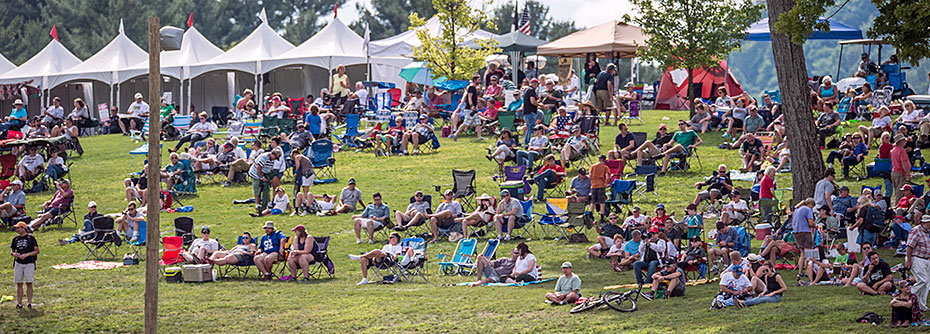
[536,20,649,58]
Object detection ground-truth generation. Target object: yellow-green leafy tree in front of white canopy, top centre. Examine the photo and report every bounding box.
[410,0,500,80]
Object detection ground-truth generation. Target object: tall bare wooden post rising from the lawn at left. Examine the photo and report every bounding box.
[144,16,161,334]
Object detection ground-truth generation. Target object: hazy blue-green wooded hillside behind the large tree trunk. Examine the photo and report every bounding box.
[729,0,930,95]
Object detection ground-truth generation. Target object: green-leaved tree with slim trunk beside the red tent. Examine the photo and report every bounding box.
[624,0,762,114]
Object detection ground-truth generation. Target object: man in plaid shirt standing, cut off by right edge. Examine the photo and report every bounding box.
[904,215,930,312]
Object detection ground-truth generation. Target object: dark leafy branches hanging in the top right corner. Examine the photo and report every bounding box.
[868,0,930,66]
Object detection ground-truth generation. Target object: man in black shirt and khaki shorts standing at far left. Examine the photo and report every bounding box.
[10,222,39,308]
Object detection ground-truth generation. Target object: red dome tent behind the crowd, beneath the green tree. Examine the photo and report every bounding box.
[656,60,743,110]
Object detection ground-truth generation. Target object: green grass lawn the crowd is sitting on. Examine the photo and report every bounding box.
[0,111,916,333]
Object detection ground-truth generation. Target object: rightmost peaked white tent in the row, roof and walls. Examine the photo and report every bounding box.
[262,18,411,94]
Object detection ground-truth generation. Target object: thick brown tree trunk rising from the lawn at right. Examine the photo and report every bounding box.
[767,0,824,200]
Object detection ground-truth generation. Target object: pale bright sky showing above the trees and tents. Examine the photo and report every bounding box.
[339,0,633,27]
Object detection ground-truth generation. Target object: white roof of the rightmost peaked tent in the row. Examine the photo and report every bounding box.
[261,18,410,73]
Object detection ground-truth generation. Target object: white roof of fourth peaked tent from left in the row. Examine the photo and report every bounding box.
[187,22,294,78]
